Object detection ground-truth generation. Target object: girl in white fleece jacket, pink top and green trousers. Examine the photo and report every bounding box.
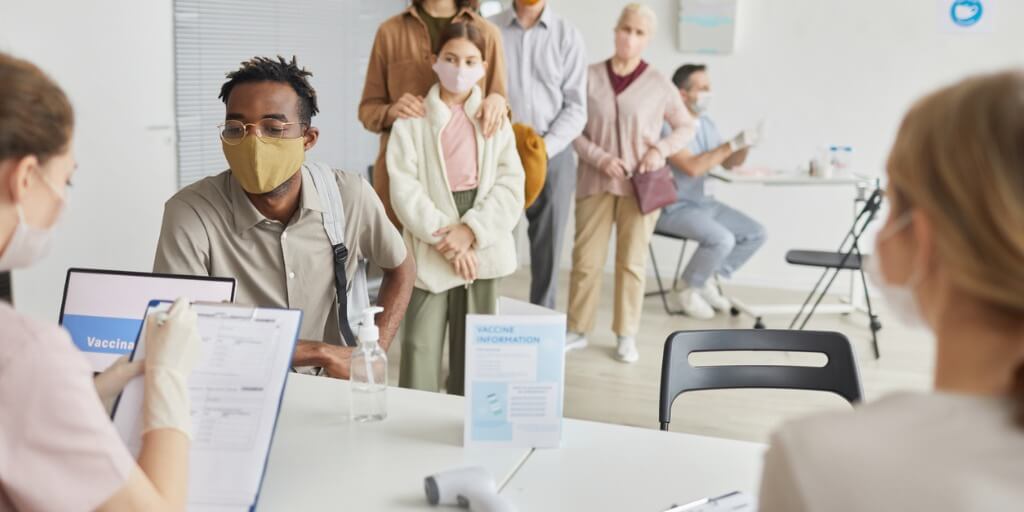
[387,23,525,394]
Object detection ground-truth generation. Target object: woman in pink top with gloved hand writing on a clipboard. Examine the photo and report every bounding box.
[0,53,199,512]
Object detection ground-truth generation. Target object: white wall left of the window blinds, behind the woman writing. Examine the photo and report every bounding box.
[0,0,176,322]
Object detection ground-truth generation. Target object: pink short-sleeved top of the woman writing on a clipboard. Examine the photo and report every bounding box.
[0,302,135,512]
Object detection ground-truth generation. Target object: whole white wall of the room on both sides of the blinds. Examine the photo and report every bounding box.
[0,0,1024,319]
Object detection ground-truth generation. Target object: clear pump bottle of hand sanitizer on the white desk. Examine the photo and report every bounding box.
[349,307,387,423]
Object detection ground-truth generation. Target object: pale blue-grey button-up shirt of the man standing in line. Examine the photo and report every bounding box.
[489,5,587,158]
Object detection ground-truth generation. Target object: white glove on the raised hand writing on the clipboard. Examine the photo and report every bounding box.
[142,298,200,439]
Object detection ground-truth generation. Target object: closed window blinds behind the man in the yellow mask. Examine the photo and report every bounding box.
[174,0,407,186]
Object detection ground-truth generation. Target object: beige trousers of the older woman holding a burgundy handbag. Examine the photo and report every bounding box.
[568,194,662,336]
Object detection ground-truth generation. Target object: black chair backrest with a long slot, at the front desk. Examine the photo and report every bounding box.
[658,329,862,430]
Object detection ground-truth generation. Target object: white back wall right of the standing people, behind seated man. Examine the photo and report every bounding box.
[549,0,1024,288]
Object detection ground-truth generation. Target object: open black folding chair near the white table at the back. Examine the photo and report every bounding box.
[785,188,884,359]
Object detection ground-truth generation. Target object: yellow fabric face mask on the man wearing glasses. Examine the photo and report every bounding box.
[220,134,306,194]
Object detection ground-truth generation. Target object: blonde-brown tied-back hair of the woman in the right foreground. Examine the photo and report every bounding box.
[887,70,1024,421]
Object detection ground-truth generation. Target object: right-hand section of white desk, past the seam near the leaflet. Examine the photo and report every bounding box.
[502,420,766,512]
